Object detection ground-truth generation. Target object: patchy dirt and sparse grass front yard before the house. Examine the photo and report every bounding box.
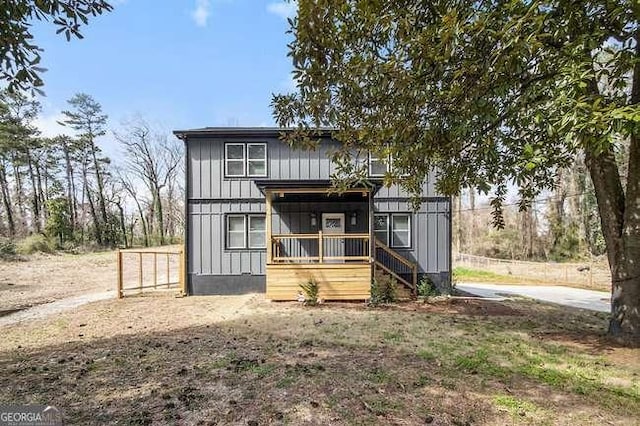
[0,251,640,425]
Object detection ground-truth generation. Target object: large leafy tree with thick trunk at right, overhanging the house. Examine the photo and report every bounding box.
[273,0,640,336]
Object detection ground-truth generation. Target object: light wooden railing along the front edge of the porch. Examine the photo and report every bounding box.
[271,231,371,263]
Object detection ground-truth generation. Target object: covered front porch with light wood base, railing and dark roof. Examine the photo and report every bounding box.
[259,181,417,300]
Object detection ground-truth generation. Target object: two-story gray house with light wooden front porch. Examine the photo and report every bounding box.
[174,128,451,300]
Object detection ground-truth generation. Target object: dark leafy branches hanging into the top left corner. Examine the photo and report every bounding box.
[0,0,112,93]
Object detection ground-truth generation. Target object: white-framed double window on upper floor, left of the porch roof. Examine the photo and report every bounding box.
[224,143,267,177]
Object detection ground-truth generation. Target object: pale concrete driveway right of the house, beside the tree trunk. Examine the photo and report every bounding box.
[456,282,611,312]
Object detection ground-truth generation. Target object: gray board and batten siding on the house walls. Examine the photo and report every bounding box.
[174,128,451,294]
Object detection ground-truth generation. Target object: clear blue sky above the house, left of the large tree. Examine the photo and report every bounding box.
[34,0,295,151]
